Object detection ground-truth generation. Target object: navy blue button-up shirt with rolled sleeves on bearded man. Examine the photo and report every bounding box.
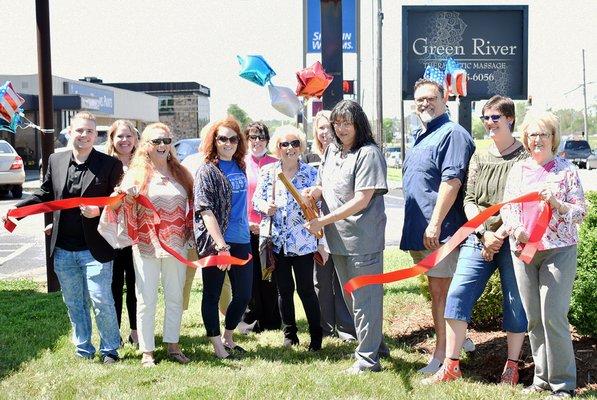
[400,114,475,250]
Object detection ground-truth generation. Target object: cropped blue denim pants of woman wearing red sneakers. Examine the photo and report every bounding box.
[444,235,527,333]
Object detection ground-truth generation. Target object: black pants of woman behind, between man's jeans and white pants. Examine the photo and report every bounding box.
[112,247,137,330]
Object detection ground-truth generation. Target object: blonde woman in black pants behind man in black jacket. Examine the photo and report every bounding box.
[107,119,139,346]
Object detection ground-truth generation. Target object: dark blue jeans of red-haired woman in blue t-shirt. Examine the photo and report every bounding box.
[201,243,253,337]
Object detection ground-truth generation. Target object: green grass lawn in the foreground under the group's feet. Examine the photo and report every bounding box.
[0,248,588,400]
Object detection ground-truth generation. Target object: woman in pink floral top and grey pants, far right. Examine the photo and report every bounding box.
[501,112,586,398]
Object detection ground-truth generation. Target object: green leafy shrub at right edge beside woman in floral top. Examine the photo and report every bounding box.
[568,192,597,337]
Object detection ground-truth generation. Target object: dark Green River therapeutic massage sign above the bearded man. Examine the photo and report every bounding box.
[402,6,528,100]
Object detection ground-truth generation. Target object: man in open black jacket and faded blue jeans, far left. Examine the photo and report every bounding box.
[3,112,122,364]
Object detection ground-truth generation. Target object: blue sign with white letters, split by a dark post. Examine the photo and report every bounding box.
[307,0,357,53]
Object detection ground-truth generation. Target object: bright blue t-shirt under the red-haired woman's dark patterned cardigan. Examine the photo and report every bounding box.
[219,160,251,244]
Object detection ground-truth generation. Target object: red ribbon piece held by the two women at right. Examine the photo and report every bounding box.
[344,192,551,293]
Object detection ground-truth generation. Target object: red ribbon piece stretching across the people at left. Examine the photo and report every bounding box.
[4,194,252,268]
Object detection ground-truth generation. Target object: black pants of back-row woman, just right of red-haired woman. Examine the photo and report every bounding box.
[243,234,282,332]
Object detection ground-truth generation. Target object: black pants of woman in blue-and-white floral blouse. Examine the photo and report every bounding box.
[274,253,323,338]
